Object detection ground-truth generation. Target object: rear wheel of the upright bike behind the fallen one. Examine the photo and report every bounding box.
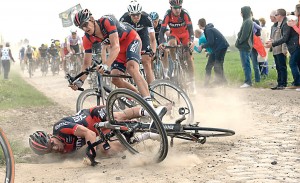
[149,79,194,124]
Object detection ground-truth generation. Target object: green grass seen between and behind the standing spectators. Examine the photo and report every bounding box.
[194,51,293,88]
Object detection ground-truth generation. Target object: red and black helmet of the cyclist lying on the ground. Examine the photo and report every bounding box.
[29,131,52,155]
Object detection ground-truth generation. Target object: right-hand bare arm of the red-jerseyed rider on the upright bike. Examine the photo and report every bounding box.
[106,32,120,66]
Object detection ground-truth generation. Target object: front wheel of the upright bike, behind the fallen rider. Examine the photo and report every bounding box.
[76,89,105,112]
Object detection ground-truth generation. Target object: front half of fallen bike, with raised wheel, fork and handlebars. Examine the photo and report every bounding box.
[86,88,168,166]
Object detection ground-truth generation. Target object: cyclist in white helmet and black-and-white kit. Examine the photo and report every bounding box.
[120,0,156,84]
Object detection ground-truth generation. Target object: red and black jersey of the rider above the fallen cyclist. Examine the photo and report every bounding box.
[83,15,136,53]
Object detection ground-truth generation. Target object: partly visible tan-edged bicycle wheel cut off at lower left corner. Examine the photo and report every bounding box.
[0,128,15,183]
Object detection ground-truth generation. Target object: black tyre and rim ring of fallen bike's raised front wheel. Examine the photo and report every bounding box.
[106,88,168,163]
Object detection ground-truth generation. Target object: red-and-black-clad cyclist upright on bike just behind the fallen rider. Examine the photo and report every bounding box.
[71,9,159,110]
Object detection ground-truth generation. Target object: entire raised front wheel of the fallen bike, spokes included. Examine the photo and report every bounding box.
[106,88,168,163]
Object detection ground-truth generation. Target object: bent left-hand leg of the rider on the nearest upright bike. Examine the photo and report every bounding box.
[111,61,138,93]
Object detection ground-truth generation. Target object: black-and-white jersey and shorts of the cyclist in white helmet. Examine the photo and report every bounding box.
[120,12,154,52]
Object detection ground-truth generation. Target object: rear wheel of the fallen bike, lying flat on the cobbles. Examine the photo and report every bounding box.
[183,126,235,137]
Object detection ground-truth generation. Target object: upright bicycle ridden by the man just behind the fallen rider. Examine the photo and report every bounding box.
[66,58,194,123]
